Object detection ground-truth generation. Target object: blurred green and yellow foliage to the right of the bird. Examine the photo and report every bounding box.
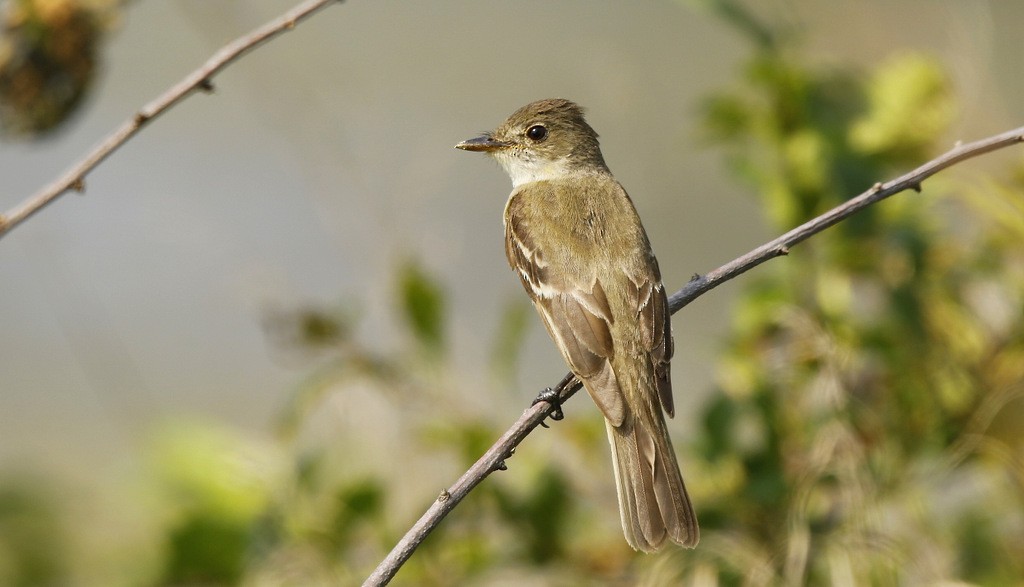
[682,5,1024,585]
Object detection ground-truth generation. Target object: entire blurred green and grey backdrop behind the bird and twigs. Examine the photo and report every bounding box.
[0,0,1024,585]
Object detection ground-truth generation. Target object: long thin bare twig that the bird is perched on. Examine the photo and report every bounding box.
[362,122,1024,587]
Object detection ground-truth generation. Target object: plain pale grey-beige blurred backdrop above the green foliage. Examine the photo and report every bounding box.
[0,0,1024,485]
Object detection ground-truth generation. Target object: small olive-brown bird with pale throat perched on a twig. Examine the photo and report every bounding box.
[456,99,698,552]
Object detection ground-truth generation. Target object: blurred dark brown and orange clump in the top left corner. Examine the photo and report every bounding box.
[0,0,118,139]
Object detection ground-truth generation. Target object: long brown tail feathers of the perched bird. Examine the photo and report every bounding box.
[607,410,699,552]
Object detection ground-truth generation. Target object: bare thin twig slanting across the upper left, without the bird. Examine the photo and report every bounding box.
[0,0,341,238]
